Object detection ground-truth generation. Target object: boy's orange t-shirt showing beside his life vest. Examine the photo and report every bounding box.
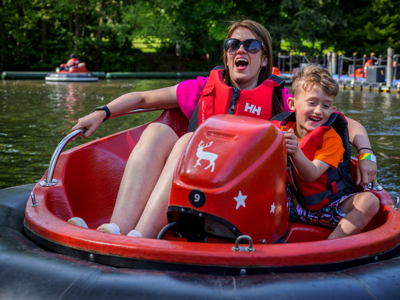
[281,122,345,169]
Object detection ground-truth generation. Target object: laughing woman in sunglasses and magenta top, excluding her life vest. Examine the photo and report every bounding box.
[69,20,376,238]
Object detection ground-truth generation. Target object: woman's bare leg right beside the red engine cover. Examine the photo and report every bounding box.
[135,133,193,238]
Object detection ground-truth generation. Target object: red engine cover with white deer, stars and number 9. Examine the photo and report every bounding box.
[170,115,289,243]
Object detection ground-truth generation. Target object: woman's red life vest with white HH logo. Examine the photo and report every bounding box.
[189,68,285,131]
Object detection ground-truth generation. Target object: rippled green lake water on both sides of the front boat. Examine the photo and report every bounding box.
[0,79,400,197]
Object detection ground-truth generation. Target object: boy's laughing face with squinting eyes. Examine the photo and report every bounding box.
[288,85,336,138]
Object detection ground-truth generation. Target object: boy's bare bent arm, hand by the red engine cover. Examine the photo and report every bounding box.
[284,129,329,182]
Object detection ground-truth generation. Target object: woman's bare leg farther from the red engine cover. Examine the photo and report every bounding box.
[110,123,178,234]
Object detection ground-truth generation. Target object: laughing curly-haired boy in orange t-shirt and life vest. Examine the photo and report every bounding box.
[281,66,379,239]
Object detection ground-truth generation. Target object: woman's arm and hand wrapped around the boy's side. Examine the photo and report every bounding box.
[346,117,377,186]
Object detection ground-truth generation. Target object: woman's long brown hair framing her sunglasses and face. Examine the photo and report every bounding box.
[223,20,283,116]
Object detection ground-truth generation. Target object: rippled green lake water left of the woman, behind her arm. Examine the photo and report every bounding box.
[0,80,179,189]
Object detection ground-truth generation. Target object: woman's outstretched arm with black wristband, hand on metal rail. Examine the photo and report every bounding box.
[72,85,179,138]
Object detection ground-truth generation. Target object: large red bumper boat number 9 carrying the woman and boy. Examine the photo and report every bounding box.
[0,110,400,299]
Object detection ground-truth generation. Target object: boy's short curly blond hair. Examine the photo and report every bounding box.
[292,65,339,98]
